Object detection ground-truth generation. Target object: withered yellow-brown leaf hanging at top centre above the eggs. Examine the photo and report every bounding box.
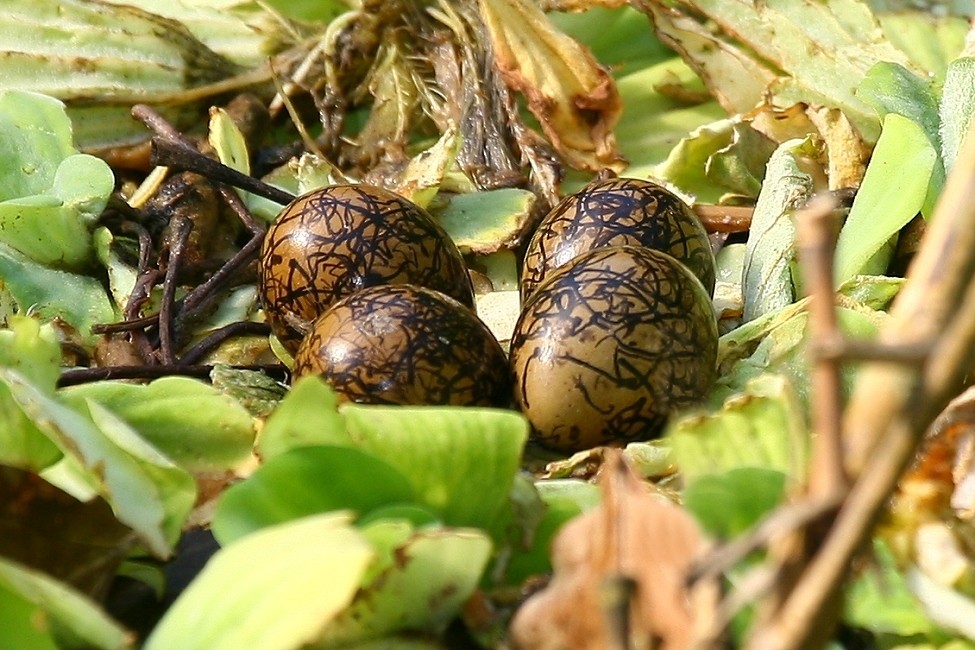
[478,0,624,171]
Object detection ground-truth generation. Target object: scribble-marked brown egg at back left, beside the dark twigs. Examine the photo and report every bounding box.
[259,185,474,352]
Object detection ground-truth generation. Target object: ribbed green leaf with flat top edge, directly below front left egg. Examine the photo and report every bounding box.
[341,404,528,528]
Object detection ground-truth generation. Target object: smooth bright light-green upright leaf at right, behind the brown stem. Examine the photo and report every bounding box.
[834,113,939,286]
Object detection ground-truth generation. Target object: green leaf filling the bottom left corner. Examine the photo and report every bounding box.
[0,558,134,650]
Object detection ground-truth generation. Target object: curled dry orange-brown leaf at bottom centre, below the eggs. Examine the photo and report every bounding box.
[511,452,717,650]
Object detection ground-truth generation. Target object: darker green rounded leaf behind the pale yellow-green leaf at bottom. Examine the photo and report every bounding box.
[213,446,416,545]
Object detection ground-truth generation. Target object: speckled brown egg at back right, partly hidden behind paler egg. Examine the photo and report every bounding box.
[521,178,715,300]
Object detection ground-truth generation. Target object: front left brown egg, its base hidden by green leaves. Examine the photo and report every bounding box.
[293,285,511,406]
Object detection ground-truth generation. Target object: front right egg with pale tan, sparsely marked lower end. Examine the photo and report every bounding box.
[510,246,718,451]
